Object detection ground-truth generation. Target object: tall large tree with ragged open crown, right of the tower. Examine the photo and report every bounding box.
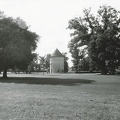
[68,6,120,74]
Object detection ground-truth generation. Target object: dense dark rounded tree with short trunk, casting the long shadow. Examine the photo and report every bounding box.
[0,11,39,78]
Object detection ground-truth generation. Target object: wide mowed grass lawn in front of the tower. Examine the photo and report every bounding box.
[0,73,120,120]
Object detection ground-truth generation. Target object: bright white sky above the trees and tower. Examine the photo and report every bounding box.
[0,0,120,66]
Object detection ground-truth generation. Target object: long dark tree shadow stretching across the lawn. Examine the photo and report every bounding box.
[0,77,95,86]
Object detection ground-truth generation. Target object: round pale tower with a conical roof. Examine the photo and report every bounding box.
[50,49,64,73]
